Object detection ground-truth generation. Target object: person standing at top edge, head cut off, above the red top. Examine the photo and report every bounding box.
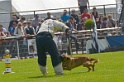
[78,0,90,14]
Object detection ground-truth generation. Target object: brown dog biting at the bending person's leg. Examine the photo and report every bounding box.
[61,54,98,72]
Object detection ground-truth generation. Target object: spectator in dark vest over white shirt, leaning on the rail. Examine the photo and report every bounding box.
[24,22,36,37]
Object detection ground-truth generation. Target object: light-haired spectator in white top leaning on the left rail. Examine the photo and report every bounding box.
[14,23,24,37]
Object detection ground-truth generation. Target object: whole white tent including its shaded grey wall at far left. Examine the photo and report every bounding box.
[0,0,116,28]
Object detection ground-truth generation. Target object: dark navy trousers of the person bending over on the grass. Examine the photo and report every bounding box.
[36,32,61,67]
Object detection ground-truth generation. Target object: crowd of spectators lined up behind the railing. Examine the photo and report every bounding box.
[0,7,117,38]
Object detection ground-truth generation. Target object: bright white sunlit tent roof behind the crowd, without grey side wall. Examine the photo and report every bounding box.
[12,0,116,14]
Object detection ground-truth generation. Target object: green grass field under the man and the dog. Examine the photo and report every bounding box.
[0,51,124,82]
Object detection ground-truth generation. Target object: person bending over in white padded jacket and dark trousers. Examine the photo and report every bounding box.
[36,19,69,75]
